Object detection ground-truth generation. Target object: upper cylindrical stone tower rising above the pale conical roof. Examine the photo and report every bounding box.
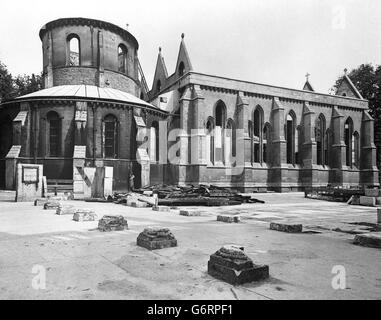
[40,18,140,97]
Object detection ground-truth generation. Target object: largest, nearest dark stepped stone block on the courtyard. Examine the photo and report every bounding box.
[208,245,269,285]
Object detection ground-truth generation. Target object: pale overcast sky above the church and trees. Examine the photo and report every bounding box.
[0,0,381,93]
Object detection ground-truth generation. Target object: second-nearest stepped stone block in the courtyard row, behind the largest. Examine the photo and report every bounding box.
[136,227,177,250]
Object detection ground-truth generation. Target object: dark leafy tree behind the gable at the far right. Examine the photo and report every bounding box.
[333,63,381,121]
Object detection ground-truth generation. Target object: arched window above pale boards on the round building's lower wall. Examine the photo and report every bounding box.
[103,114,119,158]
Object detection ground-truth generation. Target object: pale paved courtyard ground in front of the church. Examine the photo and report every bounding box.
[0,192,381,299]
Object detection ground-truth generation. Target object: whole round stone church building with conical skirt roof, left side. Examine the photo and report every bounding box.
[0,18,167,196]
